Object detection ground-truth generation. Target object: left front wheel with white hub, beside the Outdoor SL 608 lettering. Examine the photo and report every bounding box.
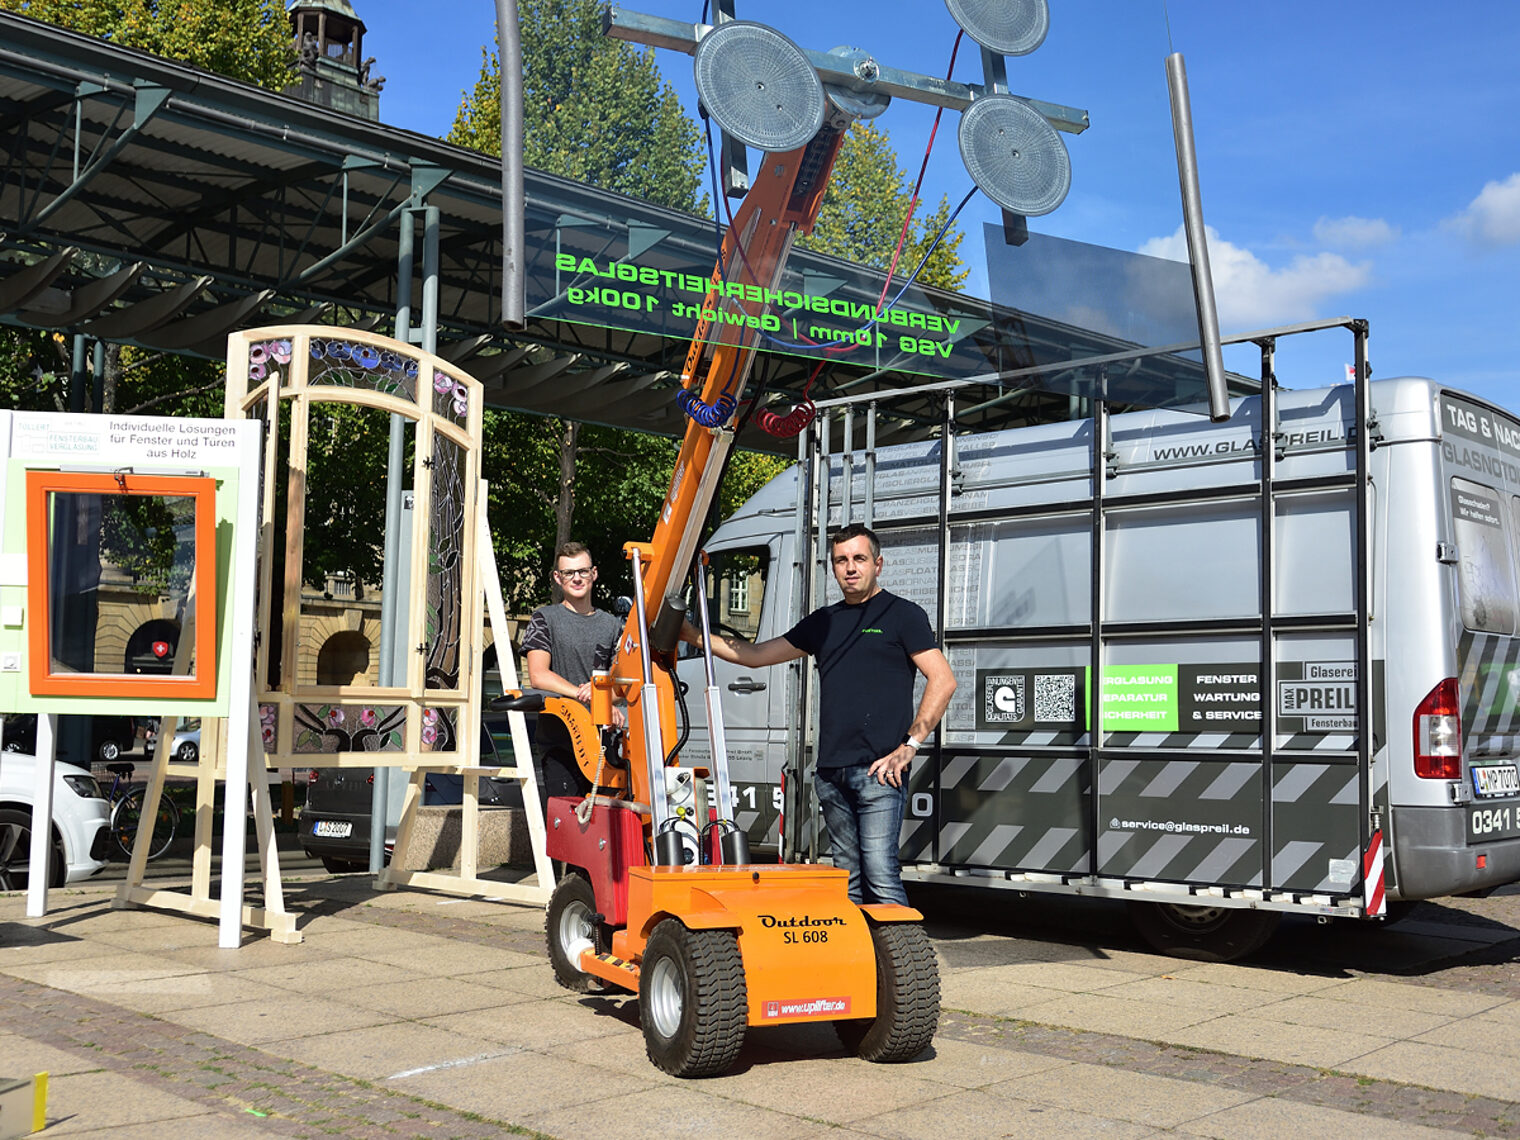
[638,918,749,1076]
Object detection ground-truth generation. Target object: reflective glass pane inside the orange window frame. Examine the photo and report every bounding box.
[47,491,196,676]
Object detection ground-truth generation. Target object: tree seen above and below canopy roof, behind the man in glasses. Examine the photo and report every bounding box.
[448,0,710,589]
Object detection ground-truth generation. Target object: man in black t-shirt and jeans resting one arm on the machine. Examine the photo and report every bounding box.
[682,523,955,906]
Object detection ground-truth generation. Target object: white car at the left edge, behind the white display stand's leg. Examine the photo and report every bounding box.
[0,751,111,891]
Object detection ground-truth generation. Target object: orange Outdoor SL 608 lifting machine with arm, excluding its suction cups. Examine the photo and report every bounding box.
[497,24,939,1076]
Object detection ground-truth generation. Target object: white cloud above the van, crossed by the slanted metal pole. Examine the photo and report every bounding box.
[1138,226,1373,333]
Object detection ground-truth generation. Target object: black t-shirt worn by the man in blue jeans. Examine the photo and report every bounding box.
[786,590,938,768]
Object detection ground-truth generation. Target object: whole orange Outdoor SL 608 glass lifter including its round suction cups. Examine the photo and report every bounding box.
[497,0,1087,1076]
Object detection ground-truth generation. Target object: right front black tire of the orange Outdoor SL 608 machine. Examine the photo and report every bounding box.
[834,923,939,1064]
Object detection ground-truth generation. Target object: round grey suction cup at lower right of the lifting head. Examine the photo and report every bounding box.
[959,94,1072,217]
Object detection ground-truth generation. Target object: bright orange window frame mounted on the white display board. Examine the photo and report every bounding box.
[26,471,216,699]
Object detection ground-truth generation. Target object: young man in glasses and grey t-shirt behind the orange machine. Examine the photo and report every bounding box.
[523,543,623,796]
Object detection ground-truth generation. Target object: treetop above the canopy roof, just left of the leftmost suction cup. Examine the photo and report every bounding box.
[448,0,708,213]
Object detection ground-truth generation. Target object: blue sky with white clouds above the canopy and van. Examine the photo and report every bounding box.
[354,0,1520,410]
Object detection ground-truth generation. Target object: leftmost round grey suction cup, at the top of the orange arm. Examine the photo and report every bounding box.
[696,20,824,150]
